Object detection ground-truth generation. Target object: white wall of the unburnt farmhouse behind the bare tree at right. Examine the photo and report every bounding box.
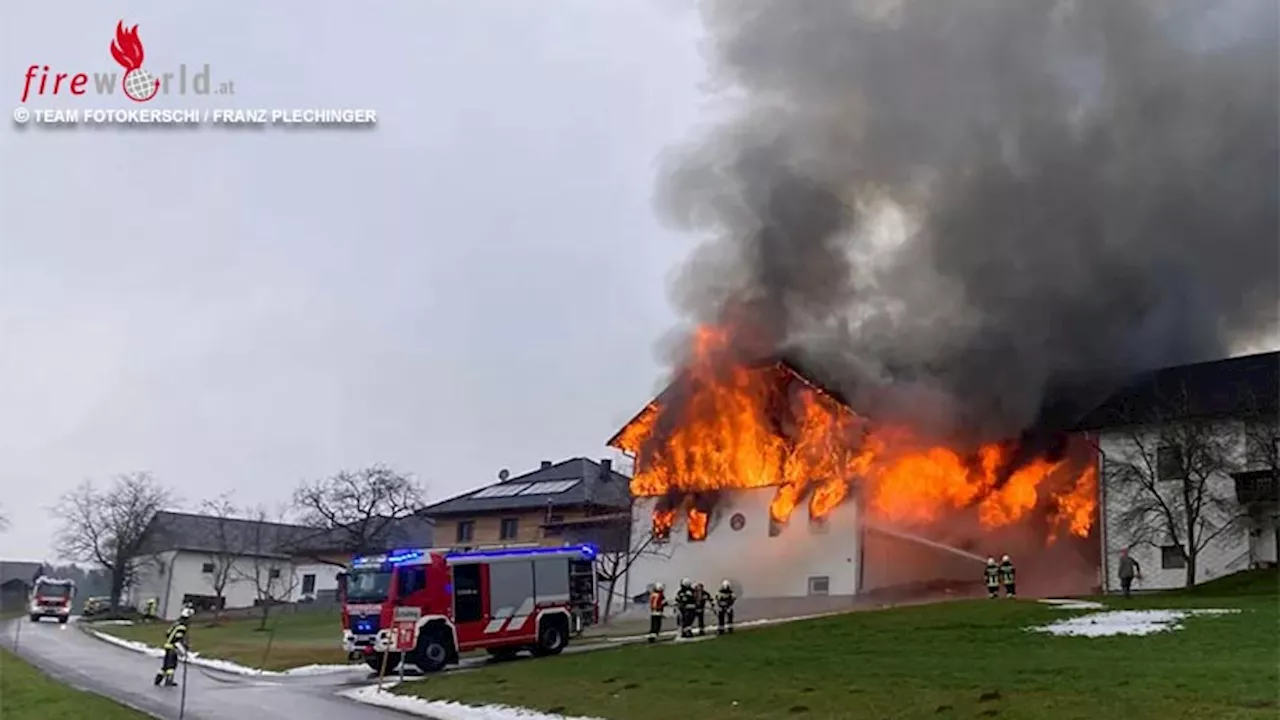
[1098,420,1275,591]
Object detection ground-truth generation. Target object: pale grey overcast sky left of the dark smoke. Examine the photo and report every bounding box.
[0,0,705,559]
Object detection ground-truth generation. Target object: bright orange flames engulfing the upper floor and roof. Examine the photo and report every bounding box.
[612,328,1097,541]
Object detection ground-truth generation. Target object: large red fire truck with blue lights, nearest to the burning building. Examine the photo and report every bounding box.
[342,544,599,673]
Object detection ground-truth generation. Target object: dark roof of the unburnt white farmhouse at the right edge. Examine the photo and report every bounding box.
[1075,351,1280,430]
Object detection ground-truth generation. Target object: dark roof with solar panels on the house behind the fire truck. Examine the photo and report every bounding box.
[422,457,631,516]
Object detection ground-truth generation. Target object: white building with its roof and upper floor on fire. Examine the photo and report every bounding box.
[609,328,1097,598]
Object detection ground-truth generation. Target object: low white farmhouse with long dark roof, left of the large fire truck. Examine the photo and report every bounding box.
[129,511,431,619]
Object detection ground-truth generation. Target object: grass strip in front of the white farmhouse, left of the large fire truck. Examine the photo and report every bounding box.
[95,611,347,670]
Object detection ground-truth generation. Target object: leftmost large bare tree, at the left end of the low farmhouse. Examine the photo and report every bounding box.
[54,473,170,609]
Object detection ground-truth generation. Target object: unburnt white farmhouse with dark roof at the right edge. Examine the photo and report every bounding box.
[1079,352,1280,592]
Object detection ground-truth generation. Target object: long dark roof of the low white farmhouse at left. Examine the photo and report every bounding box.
[143,510,431,557]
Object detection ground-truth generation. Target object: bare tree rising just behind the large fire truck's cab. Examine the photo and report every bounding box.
[293,465,422,561]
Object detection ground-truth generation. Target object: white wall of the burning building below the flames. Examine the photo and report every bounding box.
[620,487,859,598]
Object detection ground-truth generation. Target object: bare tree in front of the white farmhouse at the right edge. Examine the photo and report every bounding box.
[1103,387,1248,587]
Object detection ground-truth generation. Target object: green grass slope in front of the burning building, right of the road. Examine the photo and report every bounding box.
[397,571,1280,720]
